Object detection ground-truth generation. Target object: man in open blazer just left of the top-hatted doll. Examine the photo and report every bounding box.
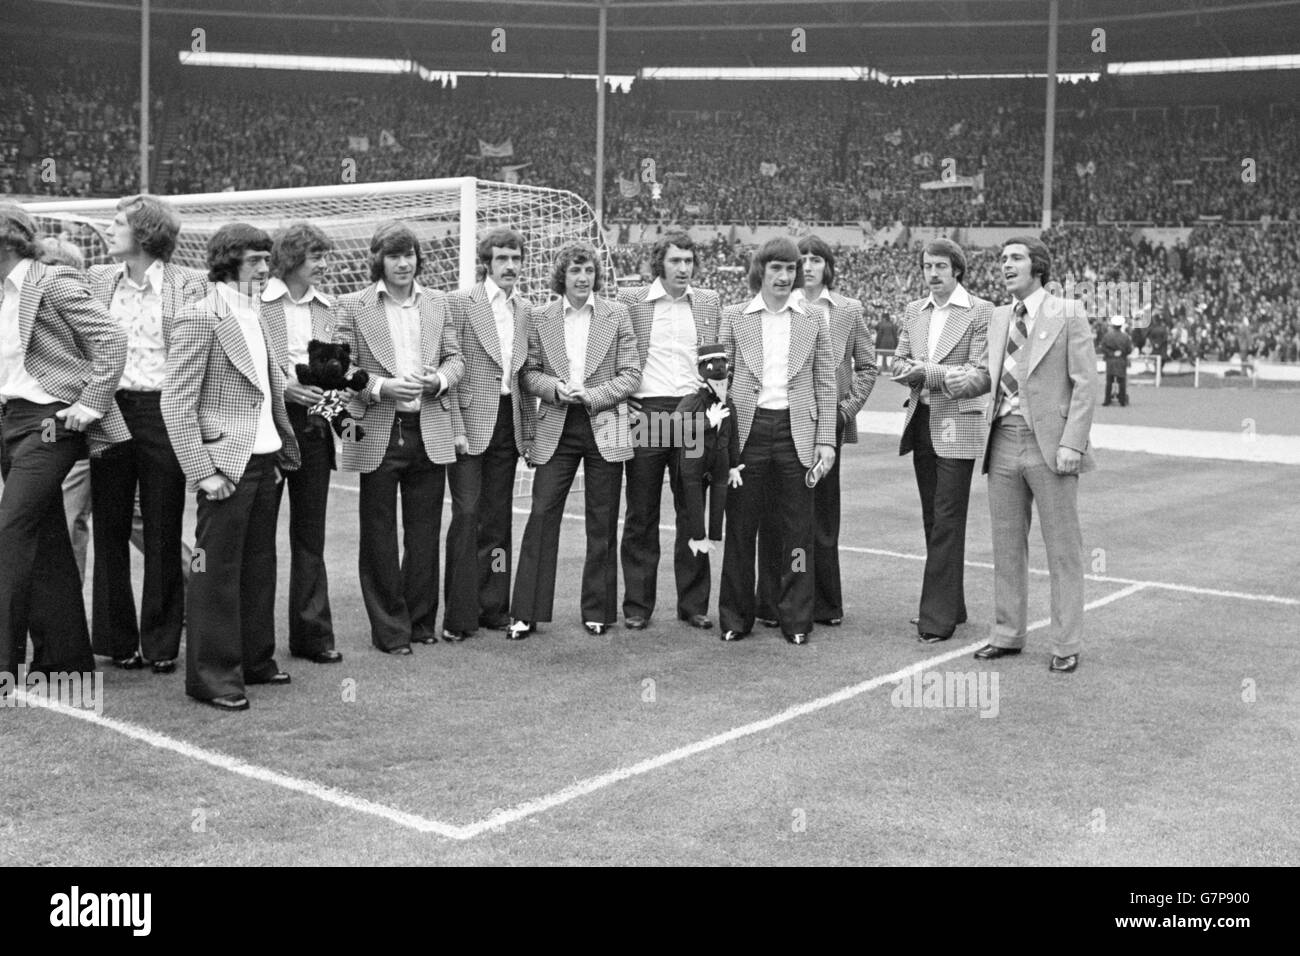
[619,232,720,631]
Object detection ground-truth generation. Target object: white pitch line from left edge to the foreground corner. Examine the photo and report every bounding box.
[16,691,472,840]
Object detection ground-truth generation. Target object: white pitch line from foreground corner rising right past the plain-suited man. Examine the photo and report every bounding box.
[462,574,1147,836]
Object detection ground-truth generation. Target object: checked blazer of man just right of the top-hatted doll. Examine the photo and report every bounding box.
[719,300,836,468]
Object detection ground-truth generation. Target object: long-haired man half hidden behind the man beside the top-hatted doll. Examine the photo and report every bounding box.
[758,235,880,627]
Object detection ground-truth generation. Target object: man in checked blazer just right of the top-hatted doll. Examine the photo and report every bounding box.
[718,238,839,644]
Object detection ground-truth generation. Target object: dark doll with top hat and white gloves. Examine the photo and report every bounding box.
[675,343,740,555]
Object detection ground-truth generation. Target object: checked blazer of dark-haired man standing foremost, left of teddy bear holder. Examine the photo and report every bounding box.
[161,287,300,490]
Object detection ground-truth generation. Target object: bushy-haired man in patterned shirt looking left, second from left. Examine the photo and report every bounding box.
[90,195,199,674]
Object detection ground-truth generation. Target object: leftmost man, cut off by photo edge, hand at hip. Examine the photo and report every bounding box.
[0,203,129,674]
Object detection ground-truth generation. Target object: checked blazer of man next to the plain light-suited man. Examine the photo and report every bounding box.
[894,287,993,460]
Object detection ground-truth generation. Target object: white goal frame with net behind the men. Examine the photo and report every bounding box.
[25,177,616,302]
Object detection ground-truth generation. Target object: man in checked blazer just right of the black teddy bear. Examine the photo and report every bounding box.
[334,221,465,657]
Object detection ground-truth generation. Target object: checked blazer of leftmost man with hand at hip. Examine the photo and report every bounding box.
[9,261,131,457]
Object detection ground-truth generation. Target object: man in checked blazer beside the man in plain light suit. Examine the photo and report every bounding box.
[892,239,993,644]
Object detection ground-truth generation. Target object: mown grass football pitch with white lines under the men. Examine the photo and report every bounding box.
[0,382,1300,866]
